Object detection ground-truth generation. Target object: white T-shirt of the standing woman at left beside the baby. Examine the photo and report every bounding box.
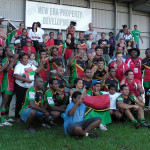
[14,63,37,88]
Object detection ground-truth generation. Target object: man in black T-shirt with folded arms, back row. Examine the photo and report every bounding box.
[98,32,110,62]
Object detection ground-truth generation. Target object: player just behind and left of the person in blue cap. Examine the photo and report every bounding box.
[82,69,93,90]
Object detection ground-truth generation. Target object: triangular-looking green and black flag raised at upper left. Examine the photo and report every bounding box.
[6,21,17,46]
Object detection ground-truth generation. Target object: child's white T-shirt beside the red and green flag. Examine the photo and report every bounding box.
[102,91,121,109]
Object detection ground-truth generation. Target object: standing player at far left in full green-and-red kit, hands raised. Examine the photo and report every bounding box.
[1,47,19,125]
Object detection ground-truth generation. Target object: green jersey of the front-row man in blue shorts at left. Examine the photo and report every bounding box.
[19,86,44,115]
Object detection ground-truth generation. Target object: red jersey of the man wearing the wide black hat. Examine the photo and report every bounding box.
[126,57,142,81]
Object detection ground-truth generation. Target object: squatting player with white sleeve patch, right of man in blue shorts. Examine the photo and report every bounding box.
[44,79,66,119]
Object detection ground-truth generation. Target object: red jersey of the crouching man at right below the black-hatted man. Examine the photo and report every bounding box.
[125,79,143,96]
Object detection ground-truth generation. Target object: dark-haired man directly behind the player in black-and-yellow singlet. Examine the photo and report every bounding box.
[87,46,108,68]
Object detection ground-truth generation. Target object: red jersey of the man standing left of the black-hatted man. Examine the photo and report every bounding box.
[110,61,129,82]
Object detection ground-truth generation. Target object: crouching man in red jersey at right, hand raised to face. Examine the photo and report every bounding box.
[120,70,144,102]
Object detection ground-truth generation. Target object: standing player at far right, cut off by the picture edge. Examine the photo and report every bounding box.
[142,48,150,110]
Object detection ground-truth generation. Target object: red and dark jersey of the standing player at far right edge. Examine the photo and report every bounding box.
[142,58,150,81]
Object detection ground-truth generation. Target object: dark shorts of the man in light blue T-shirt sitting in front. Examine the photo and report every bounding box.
[67,117,100,136]
